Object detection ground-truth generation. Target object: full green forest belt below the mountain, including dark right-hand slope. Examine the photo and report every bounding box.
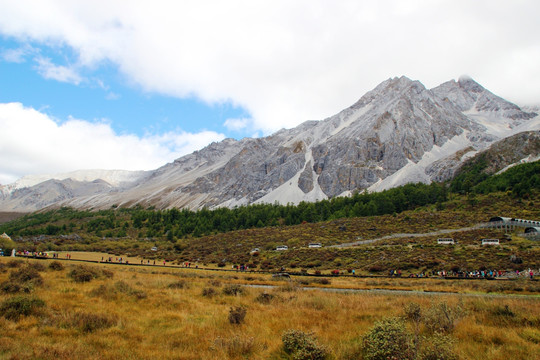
[0,157,540,241]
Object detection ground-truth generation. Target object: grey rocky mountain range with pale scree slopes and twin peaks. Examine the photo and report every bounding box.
[0,77,540,212]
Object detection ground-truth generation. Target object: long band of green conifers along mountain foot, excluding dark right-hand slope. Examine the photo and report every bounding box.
[0,183,447,241]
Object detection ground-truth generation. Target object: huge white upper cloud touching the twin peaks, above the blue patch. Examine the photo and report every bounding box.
[0,0,540,134]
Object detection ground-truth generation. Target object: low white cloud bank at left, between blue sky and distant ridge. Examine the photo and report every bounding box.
[0,103,225,184]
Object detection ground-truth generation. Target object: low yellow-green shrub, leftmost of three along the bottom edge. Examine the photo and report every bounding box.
[281,329,328,360]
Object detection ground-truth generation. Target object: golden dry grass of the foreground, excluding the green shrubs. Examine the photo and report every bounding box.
[0,258,540,360]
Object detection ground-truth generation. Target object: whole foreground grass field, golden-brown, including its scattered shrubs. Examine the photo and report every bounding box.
[0,255,540,360]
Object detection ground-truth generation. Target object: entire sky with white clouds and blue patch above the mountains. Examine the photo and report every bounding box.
[0,0,540,184]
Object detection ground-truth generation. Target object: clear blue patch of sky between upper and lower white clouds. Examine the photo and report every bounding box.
[0,36,249,138]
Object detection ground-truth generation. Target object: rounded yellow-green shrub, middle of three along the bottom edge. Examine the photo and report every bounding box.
[362,318,413,360]
